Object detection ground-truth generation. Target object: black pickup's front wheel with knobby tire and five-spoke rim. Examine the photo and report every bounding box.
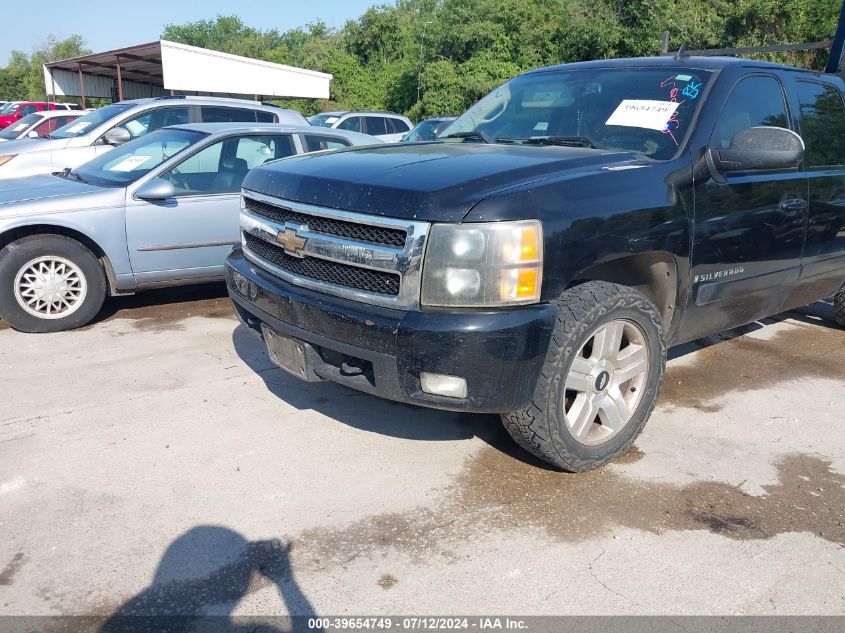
[502,281,666,472]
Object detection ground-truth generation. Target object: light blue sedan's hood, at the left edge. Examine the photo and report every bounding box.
[0,174,112,217]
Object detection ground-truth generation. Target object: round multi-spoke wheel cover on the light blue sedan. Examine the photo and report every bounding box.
[15,255,87,319]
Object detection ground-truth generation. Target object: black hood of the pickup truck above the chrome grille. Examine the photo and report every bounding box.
[243,142,635,222]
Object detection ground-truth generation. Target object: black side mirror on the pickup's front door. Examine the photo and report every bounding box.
[708,127,804,174]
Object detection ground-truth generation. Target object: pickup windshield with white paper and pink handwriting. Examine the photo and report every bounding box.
[439,67,712,160]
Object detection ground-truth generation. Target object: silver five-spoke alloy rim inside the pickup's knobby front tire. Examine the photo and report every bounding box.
[564,320,649,446]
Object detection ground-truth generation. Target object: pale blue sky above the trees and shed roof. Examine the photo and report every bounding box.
[0,0,376,66]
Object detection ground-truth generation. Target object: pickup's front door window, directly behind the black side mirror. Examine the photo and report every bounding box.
[710,76,789,149]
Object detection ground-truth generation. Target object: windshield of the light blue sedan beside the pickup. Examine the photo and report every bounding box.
[70,128,207,187]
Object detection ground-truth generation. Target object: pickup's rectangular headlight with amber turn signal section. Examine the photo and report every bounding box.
[421,220,543,308]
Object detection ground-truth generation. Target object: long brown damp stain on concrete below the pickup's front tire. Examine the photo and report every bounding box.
[286,447,845,569]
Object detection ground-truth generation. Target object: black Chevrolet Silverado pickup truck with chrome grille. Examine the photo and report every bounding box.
[227,56,845,471]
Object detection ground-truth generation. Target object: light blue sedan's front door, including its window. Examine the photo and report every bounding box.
[126,134,296,284]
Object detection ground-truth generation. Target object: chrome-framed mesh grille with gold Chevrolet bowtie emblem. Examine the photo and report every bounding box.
[241,190,429,309]
